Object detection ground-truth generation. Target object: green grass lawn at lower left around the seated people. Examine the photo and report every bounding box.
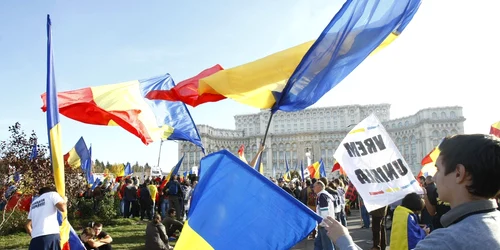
[0,220,174,250]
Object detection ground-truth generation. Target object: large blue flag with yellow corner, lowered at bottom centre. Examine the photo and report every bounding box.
[175,150,322,250]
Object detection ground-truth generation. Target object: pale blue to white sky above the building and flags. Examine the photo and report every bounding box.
[0,0,500,171]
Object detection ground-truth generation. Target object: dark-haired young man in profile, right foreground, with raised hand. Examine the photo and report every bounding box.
[325,134,500,250]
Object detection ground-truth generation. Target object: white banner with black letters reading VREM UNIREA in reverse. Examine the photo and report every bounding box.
[334,114,423,211]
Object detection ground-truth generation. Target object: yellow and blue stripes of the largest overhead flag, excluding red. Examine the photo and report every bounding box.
[198,0,421,111]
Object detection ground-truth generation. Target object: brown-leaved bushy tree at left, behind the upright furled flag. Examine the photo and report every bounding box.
[0,122,85,201]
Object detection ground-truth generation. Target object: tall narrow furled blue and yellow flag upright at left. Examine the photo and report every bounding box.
[47,15,85,250]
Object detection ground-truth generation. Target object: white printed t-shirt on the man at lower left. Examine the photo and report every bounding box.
[28,192,63,238]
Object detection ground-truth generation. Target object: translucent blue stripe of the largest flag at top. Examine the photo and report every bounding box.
[272,0,421,112]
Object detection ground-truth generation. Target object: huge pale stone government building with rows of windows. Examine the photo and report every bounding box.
[178,104,465,176]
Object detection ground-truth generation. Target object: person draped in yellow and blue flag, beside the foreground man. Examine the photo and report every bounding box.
[390,193,429,250]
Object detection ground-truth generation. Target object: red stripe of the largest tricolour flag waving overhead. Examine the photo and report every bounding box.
[146,64,226,107]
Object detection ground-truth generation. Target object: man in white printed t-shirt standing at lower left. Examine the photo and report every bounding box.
[26,187,66,250]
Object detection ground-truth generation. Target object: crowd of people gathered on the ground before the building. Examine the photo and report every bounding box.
[6,135,500,250]
